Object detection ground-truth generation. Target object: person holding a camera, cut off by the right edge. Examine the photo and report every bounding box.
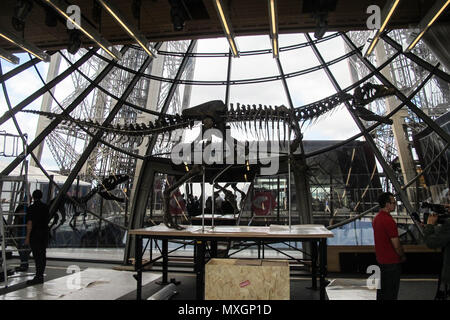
[423,208,450,299]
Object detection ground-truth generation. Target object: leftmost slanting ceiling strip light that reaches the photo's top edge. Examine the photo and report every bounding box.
[45,0,122,60]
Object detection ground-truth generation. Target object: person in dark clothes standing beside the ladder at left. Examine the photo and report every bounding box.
[25,190,49,284]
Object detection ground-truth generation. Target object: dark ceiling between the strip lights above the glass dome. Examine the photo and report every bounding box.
[0,0,450,51]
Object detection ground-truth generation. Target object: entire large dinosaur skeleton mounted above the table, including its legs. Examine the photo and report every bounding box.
[25,83,395,229]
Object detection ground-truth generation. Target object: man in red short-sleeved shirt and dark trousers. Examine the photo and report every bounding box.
[372,192,406,300]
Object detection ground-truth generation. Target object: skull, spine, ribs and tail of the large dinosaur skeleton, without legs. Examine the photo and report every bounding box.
[22,83,394,146]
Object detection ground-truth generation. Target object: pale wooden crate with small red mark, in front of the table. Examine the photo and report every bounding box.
[205,259,290,300]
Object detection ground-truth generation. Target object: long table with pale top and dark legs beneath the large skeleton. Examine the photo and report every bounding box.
[130,224,333,300]
